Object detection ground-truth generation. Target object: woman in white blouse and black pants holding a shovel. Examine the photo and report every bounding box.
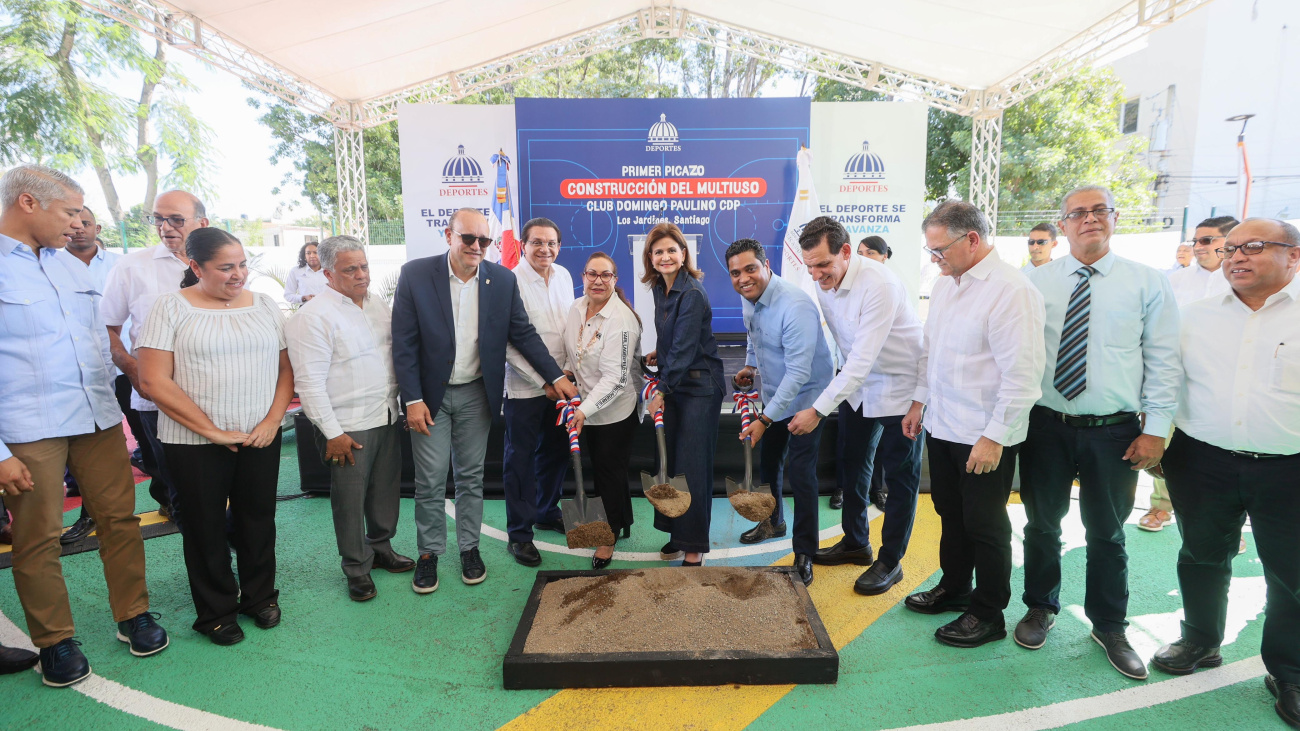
[564,251,641,568]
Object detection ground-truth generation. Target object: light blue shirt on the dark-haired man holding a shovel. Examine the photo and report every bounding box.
[741,274,835,421]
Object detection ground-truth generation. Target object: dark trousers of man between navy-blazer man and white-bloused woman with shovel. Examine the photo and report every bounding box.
[502,395,569,544]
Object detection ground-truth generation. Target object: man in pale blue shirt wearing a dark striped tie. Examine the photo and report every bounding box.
[1015,186,1182,680]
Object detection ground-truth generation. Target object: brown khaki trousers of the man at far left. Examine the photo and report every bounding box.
[5,424,150,648]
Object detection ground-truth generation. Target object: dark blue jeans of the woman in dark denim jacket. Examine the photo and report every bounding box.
[654,388,723,553]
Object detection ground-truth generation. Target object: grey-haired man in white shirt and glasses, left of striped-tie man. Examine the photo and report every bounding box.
[902,200,1044,648]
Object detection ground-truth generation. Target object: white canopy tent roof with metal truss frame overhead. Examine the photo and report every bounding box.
[78,0,1212,241]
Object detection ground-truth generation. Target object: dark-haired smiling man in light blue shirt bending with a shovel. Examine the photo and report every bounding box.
[727,238,833,584]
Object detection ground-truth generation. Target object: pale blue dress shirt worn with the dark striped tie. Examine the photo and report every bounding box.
[1026,251,1183,438]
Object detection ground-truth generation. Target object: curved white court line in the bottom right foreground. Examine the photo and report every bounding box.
[893,656,1265,731]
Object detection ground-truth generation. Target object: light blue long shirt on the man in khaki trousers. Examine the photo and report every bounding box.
[0,234,122,459]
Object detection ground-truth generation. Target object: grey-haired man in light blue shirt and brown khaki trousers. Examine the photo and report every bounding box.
[0,165,168,687]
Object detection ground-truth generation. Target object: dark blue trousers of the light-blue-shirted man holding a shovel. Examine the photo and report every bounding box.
[758,419,822,557]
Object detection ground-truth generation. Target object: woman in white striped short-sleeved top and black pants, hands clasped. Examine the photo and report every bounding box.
[135,228,294,645]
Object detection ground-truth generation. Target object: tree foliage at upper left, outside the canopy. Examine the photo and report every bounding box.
[0,0,212,222]
